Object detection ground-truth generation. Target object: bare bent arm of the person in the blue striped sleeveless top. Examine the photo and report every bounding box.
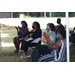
[44,33,62,49]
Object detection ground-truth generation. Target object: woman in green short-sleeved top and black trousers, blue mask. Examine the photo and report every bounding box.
[32,23,56,61]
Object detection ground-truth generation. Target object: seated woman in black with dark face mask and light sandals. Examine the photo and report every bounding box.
[20,22,42,59]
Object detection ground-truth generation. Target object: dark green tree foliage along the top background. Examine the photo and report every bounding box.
[13,12,75,18]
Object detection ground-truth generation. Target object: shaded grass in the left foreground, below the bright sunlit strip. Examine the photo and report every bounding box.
[0,46,31,62]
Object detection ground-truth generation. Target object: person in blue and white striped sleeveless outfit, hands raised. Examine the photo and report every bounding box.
[32,29,66,62]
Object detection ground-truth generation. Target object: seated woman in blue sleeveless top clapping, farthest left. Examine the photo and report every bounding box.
[13,21,28,53]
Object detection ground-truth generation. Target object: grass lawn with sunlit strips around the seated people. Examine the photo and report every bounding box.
[0,26,75,62]
